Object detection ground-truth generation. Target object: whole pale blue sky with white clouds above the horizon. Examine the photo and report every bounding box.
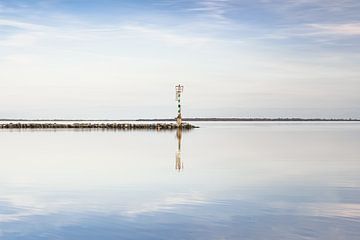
[0,0,360,119]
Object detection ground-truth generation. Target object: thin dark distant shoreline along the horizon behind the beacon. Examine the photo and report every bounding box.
[0,118,360,122]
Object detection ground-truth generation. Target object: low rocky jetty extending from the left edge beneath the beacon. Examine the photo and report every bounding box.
[0,123,196,130]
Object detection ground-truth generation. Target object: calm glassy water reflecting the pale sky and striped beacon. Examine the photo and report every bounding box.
[0,122,360,240]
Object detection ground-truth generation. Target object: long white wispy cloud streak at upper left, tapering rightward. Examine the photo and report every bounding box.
[0,15,221,47]
